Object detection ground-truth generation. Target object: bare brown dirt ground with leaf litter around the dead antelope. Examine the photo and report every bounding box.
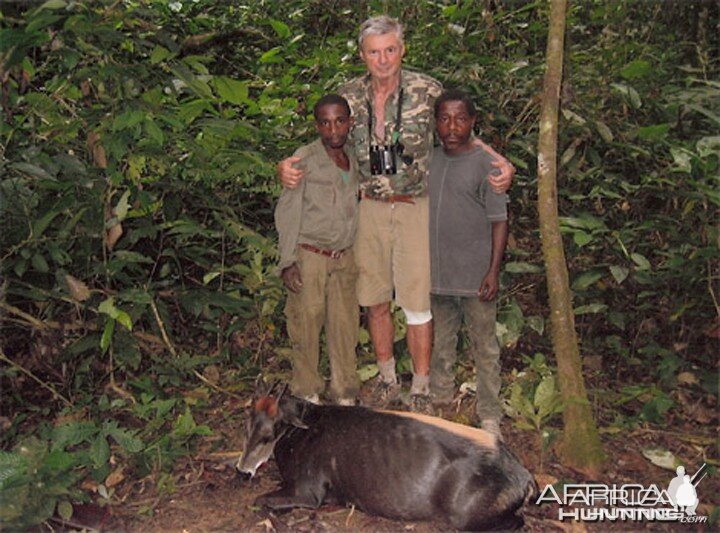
[60,390,720,533]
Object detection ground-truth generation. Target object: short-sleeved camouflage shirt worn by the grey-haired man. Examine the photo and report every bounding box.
[338,69,442,198]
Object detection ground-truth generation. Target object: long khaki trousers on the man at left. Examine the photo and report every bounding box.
[285,248,360,400]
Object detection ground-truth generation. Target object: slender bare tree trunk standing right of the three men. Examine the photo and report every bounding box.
[538,0,605,475]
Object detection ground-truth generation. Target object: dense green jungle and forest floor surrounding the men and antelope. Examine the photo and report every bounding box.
[0,0,720,531]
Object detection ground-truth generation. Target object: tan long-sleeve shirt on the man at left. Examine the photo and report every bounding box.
[275,139,358,272]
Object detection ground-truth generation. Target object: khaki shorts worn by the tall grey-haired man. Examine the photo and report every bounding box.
[355,197,430,313]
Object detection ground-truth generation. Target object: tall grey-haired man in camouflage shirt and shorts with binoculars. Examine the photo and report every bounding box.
[278,16,514,412]
